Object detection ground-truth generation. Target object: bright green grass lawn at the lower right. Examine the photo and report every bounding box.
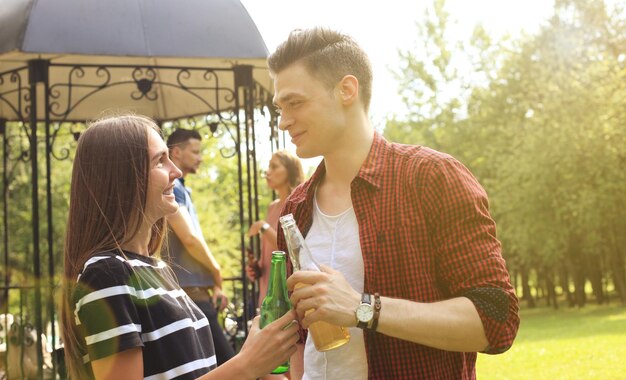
[477,304,626,380]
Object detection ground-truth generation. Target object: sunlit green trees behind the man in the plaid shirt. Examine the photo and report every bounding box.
[385,0,626,302]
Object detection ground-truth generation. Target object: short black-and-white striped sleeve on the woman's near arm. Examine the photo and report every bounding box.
[74,257,143,361]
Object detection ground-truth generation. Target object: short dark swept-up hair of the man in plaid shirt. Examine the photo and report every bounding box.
[267,27,372,111]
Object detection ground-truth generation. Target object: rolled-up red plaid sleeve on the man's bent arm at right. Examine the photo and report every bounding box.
[423,157,519,354]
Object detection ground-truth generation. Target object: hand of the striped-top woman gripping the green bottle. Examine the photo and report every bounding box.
[238,310,299,377]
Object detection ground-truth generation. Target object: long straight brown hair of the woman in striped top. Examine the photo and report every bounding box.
[61,115,166,379]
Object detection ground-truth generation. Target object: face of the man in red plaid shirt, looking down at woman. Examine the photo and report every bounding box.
[274,63,346,158]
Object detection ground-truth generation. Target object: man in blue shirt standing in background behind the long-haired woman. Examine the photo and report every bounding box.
[163,129,235,366]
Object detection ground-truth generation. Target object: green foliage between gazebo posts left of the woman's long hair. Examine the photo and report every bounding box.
[0,123,75,322]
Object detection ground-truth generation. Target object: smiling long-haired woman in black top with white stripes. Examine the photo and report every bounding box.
[62,116,298,380]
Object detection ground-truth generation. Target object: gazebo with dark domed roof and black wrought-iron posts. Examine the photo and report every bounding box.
[0,0,278,378]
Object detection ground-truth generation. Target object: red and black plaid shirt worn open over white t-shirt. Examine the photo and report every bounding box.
[278,133,519,379]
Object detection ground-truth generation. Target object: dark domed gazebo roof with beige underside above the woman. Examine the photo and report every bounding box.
[0,0,270,120]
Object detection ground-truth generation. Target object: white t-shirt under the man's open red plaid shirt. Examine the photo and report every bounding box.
[303,199,367,380]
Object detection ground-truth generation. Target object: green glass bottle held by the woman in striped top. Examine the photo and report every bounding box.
[260,251,291,374]
